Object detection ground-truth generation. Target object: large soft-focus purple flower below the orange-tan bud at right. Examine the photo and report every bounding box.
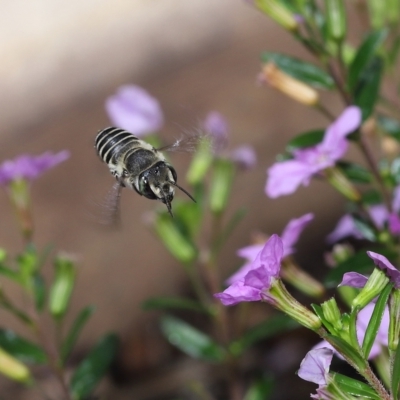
[265,106,361,198]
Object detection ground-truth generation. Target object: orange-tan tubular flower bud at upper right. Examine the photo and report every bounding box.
[261,62,319,106]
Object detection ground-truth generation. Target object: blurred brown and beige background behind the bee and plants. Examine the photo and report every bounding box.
[0,0,340,399]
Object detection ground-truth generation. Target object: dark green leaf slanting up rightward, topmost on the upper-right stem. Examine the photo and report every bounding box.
[347,29,388,90]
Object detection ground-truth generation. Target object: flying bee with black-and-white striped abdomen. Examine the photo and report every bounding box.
[95,127,195,217]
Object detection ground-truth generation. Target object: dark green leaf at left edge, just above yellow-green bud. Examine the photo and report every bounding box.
[0,329,47,364]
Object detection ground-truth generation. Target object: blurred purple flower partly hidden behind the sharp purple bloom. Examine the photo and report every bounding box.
[227,213,314,284]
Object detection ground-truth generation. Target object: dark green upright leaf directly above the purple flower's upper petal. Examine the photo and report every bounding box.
[353,57,384,121]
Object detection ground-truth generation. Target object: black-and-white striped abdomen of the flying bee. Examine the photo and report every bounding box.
[95,127,141,164]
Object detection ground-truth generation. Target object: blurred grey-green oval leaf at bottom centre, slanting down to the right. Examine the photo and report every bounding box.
[161,316,225,362]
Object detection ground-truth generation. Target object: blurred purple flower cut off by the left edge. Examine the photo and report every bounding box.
[0,150,69,186]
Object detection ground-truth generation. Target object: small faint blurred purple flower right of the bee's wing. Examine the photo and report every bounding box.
[203,111,257,169]
